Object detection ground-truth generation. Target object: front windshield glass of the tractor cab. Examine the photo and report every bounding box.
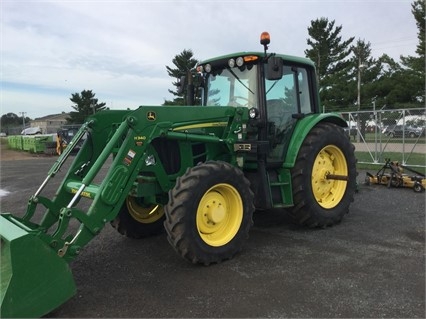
[205,65,257,108]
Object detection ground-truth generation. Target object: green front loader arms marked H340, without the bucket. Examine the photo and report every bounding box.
[3,107,246,261]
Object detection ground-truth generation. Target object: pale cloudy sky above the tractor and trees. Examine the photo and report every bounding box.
[0,0,418,119]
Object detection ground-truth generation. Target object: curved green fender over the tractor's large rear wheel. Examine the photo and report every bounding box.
[283,113,348,169]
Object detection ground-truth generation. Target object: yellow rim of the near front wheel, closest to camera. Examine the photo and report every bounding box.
[196,184,243,247]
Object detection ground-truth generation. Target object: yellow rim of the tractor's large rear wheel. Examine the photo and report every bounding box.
[312,145,348,209]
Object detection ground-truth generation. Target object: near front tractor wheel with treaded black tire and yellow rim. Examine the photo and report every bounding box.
[164,161,254,265]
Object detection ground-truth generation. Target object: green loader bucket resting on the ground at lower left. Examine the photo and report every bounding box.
[0,215,76,318]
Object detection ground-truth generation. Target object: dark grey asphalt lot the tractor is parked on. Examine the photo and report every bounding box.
[0,157,425,318]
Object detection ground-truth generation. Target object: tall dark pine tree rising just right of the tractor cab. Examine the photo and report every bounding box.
[305,18,354,108]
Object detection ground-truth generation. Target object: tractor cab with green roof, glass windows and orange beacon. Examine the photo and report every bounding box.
[196,33,319,166]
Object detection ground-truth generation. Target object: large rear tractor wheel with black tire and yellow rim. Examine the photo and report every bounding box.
[290,122,357,227]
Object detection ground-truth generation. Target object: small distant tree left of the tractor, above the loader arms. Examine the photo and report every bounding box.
[67,90,106,124]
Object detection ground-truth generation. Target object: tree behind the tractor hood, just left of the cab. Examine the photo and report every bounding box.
[163,50,198,105]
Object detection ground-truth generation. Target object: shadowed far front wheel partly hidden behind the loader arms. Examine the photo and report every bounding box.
[111,196,165,239]
